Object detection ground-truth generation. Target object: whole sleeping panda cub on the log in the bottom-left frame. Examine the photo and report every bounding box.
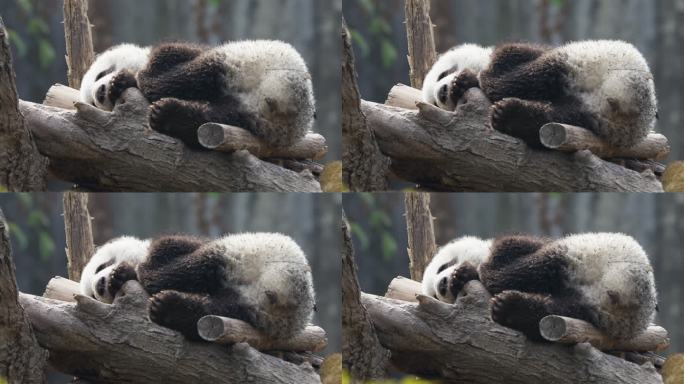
[80,233,315,340]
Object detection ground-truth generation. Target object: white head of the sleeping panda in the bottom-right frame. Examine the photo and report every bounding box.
[422,236,492,303]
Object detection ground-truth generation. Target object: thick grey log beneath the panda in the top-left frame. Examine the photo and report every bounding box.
[20,88,320,192]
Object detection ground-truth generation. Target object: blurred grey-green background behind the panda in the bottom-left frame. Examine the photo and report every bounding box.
[0,193,342,383]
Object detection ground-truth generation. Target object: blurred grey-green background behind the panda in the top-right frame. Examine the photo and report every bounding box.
[343,0,684,161]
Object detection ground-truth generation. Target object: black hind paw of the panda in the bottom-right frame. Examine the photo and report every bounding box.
[490,291,550,340]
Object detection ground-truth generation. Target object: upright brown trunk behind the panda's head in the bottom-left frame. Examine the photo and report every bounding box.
[62,192,95,281]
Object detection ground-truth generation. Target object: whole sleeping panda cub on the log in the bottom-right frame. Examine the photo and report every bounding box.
[423,233,656,341]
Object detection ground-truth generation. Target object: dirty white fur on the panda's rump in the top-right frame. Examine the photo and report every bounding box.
[548,40,658,147]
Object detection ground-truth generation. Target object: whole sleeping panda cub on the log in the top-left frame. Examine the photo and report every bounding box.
[81,40,315,149]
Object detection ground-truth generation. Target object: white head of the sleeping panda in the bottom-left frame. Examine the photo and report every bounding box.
[80,236,150,303]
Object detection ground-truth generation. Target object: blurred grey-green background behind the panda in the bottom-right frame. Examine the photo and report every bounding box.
[342,193,684,354]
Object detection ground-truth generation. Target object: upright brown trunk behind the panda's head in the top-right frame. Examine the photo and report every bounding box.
[404,0,437,88]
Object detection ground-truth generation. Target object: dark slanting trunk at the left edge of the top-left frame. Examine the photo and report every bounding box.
[0,17,48,191]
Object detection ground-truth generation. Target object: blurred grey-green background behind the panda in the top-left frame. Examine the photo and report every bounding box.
[0,0,342,160]
